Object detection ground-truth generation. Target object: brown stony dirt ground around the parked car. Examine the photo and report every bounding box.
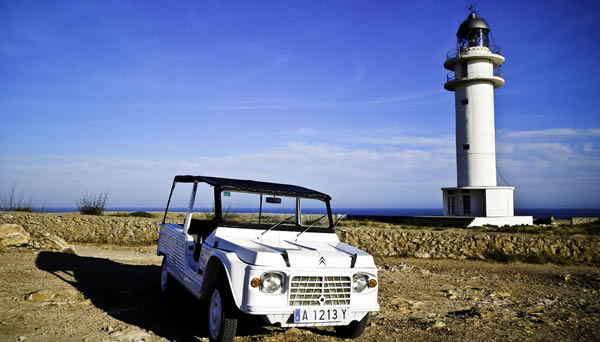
[0,245,600,341]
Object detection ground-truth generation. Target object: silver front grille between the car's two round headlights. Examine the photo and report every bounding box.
[290,276,351,306]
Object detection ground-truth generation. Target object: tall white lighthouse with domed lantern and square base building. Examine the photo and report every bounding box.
[442,10,532,225]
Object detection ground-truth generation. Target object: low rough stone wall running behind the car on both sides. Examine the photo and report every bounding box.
[0,212,600,265]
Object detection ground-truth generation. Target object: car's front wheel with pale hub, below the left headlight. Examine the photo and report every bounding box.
[208,287,237,342]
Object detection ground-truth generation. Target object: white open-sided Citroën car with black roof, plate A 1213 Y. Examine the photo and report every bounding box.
[157,176,379,341]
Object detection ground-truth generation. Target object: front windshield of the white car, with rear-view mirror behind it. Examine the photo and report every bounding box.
[220,191,332,232]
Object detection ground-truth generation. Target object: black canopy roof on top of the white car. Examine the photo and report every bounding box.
[174,175,331,200]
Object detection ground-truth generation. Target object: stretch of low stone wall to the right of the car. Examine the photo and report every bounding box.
[338,228,600,265]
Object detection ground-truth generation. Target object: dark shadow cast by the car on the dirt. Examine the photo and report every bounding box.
[36,252,274,341]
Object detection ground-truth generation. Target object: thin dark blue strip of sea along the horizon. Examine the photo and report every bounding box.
[36,207,600,219]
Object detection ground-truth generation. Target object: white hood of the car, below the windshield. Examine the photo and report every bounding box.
[205,228,375,268]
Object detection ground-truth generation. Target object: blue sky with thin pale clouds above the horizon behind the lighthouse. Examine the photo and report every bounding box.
[0,0,600,208]
